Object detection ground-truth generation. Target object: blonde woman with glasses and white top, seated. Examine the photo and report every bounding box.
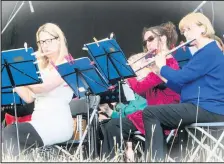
[2,23,74,156]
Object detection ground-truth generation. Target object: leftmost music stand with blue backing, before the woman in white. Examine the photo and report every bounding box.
[1,47,42,155]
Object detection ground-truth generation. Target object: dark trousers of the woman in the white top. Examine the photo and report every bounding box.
[2,123,44,156]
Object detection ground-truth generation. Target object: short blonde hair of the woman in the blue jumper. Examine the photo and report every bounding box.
[179,13,215,39]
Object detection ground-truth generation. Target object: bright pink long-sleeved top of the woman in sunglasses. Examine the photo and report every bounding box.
[127,58,180,134]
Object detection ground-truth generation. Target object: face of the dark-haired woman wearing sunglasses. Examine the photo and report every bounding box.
[143,31,160,52]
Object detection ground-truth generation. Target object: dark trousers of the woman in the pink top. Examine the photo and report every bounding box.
[101,117,137,159]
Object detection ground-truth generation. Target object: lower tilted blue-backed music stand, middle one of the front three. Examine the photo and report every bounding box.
[57,57,110,159]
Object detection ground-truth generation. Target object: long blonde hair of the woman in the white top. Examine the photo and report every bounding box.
[36,23,68,69]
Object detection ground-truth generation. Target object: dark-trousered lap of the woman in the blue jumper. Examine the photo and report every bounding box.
[143,103,221,128]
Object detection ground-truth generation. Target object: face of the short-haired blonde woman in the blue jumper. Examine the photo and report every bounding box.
[182,24,205,44]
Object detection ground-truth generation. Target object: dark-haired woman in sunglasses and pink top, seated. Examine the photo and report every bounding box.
[102,22,182,158]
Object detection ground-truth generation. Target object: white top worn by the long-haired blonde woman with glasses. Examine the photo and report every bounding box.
[30,70,74,145]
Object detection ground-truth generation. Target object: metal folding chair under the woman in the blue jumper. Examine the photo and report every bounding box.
[185,122,224,162]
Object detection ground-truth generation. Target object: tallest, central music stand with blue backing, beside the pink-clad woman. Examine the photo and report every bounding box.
[83,38,136,157]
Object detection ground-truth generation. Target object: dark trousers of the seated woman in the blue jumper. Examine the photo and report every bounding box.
[143,103,224,161]
